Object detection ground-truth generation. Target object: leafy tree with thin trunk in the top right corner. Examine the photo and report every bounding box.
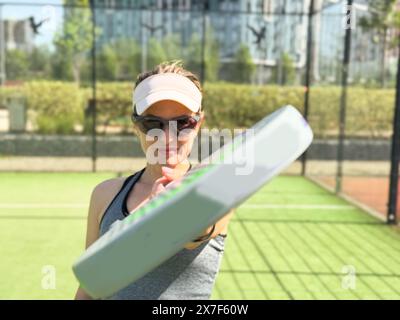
[360,0,398,87]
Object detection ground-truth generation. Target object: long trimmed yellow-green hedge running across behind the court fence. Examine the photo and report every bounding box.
[0,81,395,137]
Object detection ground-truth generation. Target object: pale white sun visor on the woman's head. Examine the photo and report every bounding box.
[133,72,202,115]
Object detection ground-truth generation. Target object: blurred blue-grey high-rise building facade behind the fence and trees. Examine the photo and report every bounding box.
[83,0,396,83]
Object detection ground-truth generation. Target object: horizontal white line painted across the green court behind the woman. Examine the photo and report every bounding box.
[0,203,355,210]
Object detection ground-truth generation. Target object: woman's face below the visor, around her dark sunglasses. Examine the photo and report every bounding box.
[134,100,204,167]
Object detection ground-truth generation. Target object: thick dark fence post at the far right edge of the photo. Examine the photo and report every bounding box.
[387,45,400,224]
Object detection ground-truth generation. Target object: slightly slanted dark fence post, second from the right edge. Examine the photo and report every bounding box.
[336,0,353,193]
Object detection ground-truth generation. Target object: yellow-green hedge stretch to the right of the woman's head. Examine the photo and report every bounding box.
[203,82,395,137]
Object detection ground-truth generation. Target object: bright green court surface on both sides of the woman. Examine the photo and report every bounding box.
[0,173,400,299]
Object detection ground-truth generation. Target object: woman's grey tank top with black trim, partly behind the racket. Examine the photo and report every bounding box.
[100,168,226,300]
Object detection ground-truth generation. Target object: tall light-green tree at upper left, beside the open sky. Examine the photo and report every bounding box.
[54,0,98,85]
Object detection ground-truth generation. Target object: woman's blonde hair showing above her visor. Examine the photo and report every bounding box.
[135,60,203,93]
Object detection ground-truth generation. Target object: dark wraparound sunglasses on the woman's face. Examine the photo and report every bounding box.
[132,113,201,134]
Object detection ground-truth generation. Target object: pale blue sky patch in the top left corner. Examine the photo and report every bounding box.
[0,0,63,47]
